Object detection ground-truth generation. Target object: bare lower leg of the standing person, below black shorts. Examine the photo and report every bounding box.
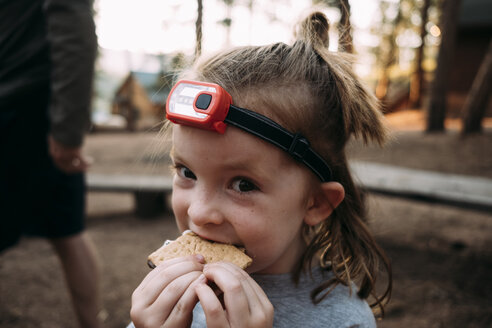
[50,232,101,327]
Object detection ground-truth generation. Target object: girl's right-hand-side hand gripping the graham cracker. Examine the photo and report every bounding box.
[195,262,273,328]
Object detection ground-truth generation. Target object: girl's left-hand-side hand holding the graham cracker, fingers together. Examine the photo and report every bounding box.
[130,255,206,328]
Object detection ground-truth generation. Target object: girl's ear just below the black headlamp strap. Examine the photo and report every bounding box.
[304,182,345,226]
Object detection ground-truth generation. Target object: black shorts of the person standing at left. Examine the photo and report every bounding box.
[0,88,86,251]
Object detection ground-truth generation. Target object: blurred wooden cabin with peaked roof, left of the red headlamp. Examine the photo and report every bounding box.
[111,71,169,131]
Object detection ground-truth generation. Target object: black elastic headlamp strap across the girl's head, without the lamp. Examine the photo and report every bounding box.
[224,105,332,182]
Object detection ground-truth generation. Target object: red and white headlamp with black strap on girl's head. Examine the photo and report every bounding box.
[166,80,332,182]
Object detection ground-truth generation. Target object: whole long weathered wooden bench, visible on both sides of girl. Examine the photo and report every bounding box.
[87,161,492,217]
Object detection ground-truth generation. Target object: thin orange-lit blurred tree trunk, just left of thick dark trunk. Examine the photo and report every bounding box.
[409,0,431,108]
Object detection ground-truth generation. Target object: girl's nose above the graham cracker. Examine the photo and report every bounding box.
[188,194,224,226]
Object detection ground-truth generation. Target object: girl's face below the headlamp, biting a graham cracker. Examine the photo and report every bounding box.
[172,125,312,274]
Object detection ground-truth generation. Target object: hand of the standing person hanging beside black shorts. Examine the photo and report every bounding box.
[48,136,90,174]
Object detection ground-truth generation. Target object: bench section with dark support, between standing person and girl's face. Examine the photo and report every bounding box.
[87,173,172,217]
